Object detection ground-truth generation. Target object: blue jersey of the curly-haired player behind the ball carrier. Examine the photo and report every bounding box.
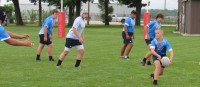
[147,20,161,39]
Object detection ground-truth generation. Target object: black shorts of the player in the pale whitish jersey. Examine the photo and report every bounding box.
[65,38,82,48]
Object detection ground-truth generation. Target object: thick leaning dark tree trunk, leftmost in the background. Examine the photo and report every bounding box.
[12,0,24,25]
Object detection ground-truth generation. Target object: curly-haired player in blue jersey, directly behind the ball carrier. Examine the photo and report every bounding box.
[141,14,164,66]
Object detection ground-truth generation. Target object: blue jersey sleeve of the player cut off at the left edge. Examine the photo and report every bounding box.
[0,25,10,41]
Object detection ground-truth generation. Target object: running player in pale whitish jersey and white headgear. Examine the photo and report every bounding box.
[57,10,88,67]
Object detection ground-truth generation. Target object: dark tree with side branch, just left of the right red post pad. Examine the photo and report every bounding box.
[118,0,146,26]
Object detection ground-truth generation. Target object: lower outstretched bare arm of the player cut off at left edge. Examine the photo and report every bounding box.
[5,38,33,47]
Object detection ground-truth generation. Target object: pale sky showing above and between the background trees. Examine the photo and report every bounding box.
[0,0,178,10]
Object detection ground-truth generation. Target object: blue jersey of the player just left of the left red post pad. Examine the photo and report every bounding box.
[39,16,56,34]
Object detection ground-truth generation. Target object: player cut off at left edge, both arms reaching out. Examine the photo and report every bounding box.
[0,6,33,47]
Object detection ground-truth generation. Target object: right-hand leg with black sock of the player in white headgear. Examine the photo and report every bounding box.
[74,45,84,67]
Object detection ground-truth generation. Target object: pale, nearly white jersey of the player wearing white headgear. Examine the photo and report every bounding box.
[66,16,85,40]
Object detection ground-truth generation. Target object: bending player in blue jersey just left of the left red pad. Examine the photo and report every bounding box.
[36,9,58,61]
